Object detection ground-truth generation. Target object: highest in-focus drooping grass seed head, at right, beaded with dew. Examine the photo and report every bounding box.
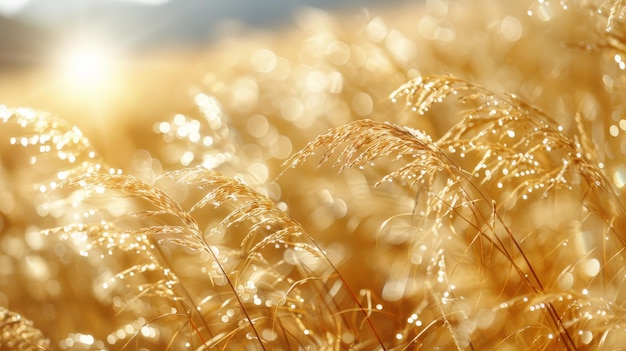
[391,76,617,215]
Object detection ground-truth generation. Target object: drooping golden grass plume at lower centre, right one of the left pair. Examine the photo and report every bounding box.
[167,168,388,347]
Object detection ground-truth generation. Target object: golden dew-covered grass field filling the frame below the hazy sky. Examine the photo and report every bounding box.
[0,1,626,350]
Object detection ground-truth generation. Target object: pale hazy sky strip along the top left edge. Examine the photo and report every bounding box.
[0,0,405,48]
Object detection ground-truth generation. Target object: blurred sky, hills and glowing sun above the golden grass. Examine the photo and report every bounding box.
[0,0,415,167]
